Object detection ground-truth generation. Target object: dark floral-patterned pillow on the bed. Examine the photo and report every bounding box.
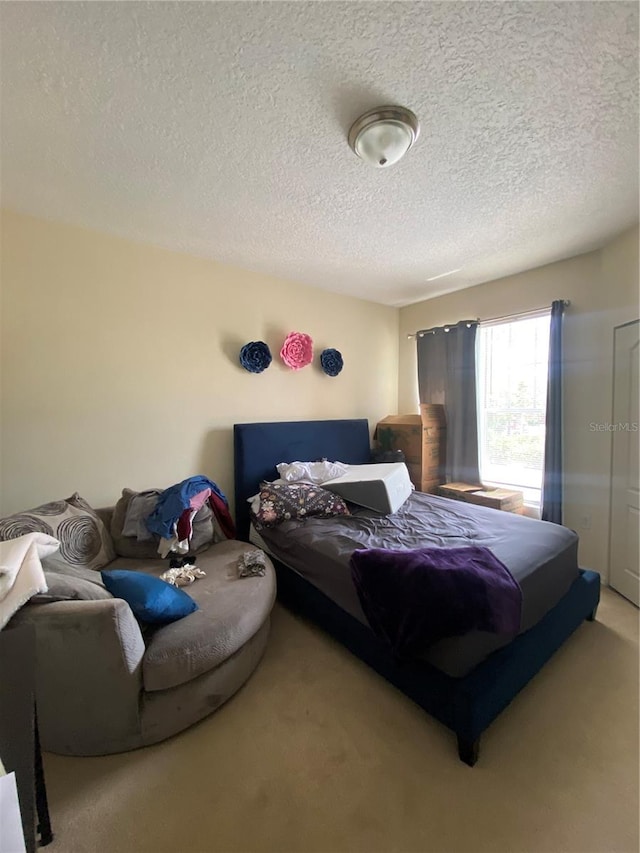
[252,482,351,530]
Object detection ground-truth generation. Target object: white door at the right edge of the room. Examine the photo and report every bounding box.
[609,320,640,606]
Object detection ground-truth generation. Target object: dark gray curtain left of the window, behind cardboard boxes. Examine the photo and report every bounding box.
[417,320,480,485]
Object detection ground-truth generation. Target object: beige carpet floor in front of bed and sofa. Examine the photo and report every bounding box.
[45,590,638,853]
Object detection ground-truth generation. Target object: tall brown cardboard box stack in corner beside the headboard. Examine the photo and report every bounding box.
[374,405,446,491]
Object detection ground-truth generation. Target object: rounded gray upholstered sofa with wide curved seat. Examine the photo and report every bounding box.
[5,502,276,755]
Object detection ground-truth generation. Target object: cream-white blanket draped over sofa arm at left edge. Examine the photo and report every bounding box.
[0,533,60,629]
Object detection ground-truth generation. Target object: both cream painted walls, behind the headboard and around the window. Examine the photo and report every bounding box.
[0,211,639,579]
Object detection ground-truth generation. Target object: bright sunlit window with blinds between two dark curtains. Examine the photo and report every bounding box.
[477,311,549,507]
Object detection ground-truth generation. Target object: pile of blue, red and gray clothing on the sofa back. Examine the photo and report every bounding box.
[122,475,236,558]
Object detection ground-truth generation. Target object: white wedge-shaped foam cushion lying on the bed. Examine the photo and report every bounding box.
[322,462,413,515]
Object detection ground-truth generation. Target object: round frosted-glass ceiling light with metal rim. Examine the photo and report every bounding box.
[349,106,420,169]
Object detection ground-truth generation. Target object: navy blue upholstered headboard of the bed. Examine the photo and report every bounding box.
[233,418,371,540]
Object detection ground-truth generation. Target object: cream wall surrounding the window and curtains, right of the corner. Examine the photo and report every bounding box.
[398,228,639,581]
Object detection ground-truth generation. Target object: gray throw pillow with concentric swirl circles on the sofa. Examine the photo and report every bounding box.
[0,492,115,571]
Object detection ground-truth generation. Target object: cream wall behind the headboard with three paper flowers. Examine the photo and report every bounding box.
[0,211,398,514]
